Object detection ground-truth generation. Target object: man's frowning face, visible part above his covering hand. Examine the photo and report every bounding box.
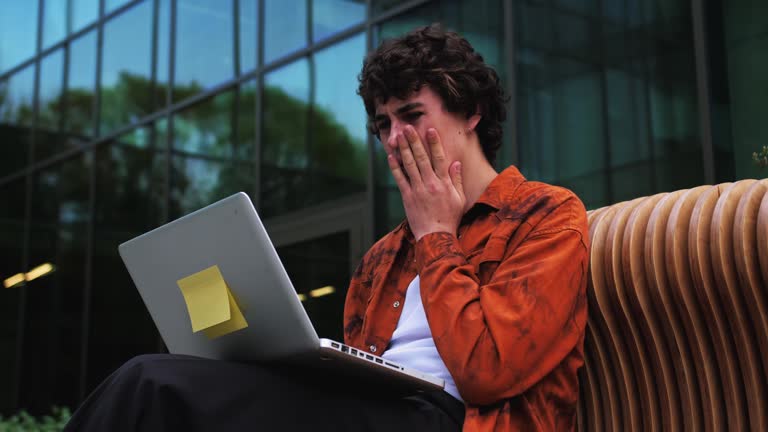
[374,86,469,169]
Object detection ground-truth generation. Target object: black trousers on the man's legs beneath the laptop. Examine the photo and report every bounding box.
[65,354,464,432]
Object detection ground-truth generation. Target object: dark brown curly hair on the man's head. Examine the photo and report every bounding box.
[357,24,508,164]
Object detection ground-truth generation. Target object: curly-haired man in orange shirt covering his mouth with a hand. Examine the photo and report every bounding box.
[68,26,588,431]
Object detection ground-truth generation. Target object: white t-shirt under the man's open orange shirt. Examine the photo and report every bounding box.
[382,275,464,402]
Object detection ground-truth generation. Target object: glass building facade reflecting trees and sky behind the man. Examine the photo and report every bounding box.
[0,0,768,414]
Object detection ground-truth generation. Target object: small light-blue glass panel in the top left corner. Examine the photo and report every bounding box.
[0,1,38,72]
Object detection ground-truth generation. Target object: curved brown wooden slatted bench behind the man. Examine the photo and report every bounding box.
[578,180,768,431]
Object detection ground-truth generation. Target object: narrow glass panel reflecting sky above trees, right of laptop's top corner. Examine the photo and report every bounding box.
[260,59,309,218]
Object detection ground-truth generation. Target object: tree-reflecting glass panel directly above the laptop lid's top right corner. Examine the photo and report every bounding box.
[170,85,255,218]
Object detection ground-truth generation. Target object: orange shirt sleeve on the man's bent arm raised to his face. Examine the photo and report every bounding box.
[416,200,588,405]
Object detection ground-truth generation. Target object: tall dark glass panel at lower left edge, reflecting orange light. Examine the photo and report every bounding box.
[0,179,27,413]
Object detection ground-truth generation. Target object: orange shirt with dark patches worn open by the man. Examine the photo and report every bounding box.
[344,167,589,431]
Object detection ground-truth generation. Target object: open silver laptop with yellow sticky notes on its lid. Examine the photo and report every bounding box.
[119,192,445,391]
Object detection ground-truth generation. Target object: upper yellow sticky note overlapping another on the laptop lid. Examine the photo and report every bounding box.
[176,266,231,332]
